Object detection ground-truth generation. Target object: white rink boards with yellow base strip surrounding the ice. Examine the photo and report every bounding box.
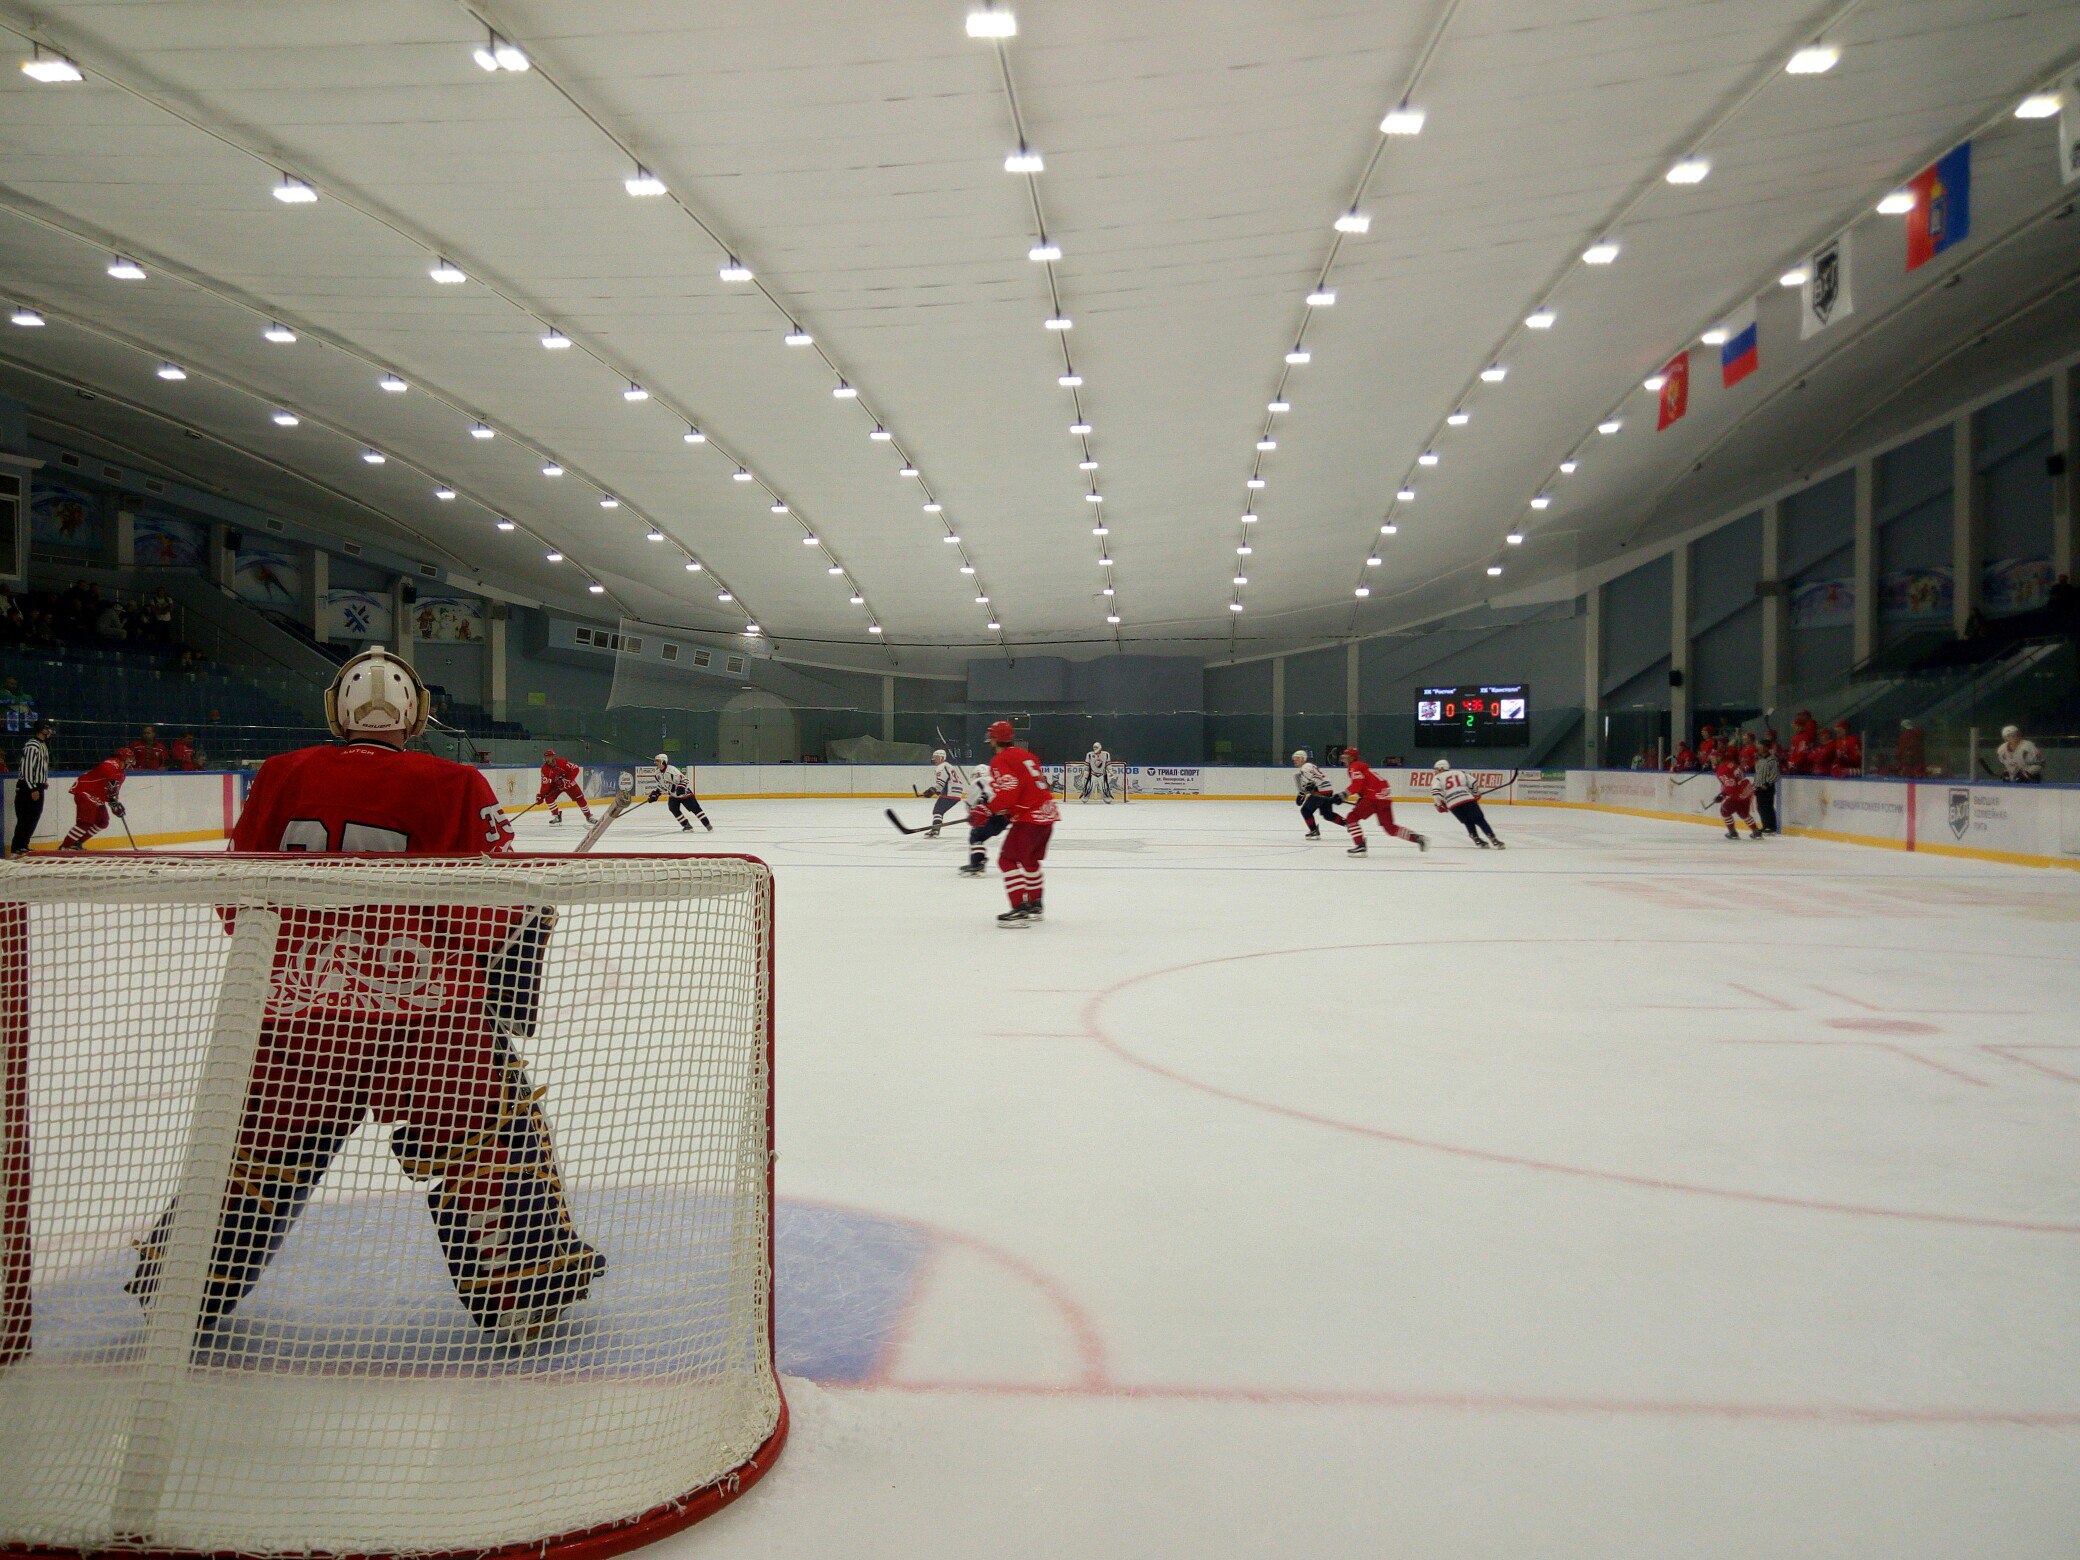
[20,763,2080,869]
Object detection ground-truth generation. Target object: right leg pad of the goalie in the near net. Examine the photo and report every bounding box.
[379,1028,607,1342]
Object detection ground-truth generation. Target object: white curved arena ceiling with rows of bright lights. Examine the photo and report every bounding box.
[0,0,2080,666]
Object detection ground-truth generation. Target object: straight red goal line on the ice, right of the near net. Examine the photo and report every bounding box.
[828,1381,2080,1429]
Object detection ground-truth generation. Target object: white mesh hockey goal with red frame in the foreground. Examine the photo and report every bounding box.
[0,857,786,1560]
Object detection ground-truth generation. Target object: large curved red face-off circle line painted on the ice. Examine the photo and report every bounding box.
[1084,938,2080,1236]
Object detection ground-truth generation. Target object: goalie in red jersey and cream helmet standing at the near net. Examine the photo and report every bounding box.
[127,649,605,1344]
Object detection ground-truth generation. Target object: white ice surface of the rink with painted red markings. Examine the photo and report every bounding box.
[490,801,2080,1560]
